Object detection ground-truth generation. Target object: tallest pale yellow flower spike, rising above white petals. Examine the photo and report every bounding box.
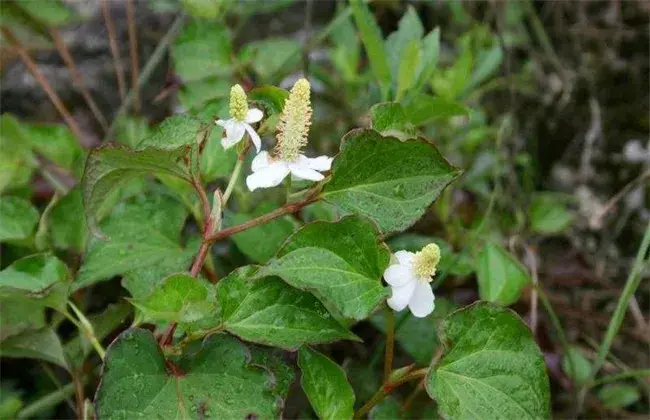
[273,79,311,161]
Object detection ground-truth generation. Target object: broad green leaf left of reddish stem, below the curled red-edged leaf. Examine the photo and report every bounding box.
[74,194,192,289]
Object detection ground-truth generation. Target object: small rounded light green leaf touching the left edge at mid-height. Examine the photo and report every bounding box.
[0,196,39,242]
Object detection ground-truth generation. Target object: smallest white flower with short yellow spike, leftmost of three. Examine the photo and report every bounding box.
[215,85,264,152]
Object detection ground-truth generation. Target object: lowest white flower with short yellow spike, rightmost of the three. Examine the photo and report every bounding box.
[384,244,440,318]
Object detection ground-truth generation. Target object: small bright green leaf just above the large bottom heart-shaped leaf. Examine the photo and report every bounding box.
[131,274,216,324]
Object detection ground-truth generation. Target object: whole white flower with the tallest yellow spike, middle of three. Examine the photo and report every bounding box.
[246,79,332,191]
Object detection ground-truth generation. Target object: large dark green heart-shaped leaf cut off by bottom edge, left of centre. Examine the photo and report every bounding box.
[95,328,284,419]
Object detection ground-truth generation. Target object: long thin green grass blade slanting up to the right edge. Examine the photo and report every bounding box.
[579,223,650,407]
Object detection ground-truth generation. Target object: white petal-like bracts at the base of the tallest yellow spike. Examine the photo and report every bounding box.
[246,151,332,191]
